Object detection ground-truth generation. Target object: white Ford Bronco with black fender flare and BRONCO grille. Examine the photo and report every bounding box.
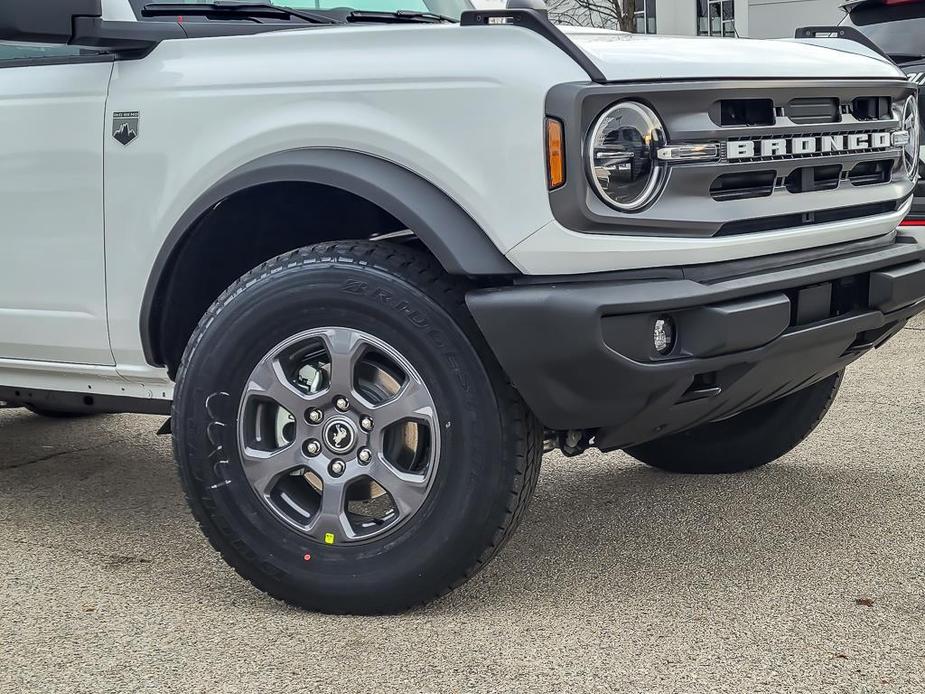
[0,0,925,613]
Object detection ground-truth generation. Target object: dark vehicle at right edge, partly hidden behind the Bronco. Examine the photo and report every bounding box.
[841,0,925,226]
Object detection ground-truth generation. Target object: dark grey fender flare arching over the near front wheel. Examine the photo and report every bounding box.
[140,148,520,365]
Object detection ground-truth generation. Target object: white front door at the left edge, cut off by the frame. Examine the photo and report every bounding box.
[0,44,113,364]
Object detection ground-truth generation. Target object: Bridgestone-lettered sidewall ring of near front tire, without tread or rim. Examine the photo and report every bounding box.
[175,258,514,604]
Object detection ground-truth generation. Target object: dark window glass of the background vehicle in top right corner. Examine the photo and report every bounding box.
[844,2,925,62]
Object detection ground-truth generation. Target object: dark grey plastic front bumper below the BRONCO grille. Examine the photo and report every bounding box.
[467,229,925,450]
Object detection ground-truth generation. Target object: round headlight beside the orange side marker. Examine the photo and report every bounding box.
[588,101,666,212]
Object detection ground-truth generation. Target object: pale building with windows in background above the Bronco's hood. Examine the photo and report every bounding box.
[473,0,845,39]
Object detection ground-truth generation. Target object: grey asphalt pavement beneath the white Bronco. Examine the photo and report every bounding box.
[0,320,925,694]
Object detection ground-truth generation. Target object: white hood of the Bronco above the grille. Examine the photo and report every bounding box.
[560,26,904,81]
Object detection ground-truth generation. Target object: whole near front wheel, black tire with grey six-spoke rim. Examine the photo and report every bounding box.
[173,243,542,614]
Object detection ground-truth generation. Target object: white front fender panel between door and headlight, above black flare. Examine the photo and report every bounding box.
[106,25,587,376]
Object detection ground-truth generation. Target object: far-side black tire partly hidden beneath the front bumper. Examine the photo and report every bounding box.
[626,372,843,475]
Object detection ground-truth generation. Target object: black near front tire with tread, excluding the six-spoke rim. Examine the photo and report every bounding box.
[173,242,542,614]
